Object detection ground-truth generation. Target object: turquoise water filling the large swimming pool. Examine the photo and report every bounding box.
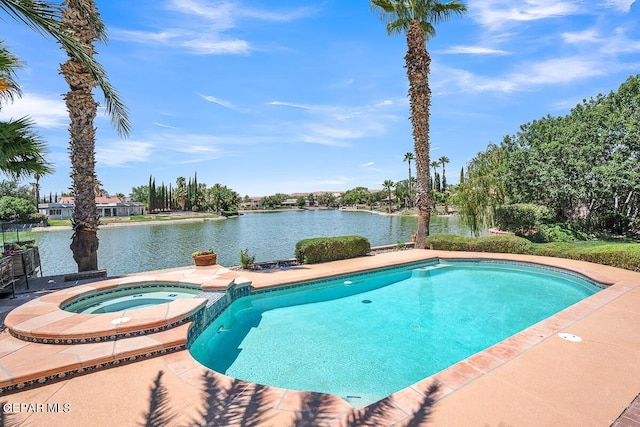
[190,262,600,406]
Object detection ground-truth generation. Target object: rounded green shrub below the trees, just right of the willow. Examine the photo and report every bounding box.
[495,203,552,236]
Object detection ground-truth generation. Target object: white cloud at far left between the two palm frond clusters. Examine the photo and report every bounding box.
[0,93,69,128]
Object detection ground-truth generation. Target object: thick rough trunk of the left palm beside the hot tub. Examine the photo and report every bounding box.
[60,0,100,272]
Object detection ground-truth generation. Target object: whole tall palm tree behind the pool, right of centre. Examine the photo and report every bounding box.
[370,0,467,249]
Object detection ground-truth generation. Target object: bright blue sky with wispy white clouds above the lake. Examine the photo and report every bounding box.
[0,0,640,196]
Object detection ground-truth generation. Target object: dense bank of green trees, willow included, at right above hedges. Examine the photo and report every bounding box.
[458,75,640,239]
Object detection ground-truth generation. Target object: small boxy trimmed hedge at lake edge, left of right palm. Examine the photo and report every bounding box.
[295,236,371,264]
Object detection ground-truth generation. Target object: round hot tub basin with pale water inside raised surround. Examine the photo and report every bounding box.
[60,282,202,314]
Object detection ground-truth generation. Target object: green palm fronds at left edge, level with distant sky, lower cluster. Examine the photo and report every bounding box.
[0,117,53,179]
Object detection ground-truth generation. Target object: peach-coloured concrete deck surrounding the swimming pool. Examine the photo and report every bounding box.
[0,250,640,427]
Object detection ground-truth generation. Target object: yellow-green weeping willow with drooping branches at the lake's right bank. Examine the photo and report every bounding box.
[458,144,506,236]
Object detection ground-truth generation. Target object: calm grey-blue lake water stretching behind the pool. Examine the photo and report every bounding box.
[20,210,470,276]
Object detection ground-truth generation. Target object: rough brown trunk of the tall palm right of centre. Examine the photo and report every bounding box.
[404,19,432,249]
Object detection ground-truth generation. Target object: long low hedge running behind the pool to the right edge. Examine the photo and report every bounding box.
[427,234,640,271]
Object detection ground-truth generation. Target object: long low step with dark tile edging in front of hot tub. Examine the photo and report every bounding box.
[0,322,191,395]
